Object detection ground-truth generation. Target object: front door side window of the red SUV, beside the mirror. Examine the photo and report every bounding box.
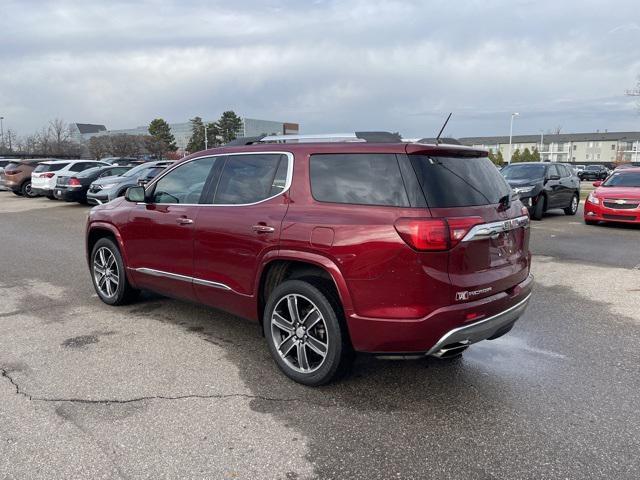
[153,157,215,203]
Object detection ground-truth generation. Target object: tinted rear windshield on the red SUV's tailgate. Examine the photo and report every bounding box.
[409,155,511,208]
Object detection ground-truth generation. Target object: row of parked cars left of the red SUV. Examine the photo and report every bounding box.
[0,158,173,205]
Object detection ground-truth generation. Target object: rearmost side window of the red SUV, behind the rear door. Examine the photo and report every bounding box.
[310,153,409,207]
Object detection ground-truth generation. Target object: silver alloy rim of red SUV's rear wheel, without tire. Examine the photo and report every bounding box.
[271,294,329,373]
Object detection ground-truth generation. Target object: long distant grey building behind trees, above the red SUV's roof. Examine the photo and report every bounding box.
[99,118,300,151]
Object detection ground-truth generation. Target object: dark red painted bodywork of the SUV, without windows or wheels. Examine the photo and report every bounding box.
[87,143,532,353]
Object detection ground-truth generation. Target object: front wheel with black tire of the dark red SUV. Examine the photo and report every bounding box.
[89,238,140,306]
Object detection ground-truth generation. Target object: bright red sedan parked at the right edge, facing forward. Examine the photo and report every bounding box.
[584,168,640,225]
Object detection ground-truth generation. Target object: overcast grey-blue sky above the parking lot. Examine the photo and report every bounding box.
[0,0,640,137]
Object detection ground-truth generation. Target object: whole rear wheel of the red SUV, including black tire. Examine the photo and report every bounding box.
[263,278,353,387]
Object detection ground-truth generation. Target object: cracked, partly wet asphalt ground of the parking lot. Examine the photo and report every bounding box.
[0,192,640,479]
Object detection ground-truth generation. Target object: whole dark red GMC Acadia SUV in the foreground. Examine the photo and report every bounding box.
[86,132,532,385]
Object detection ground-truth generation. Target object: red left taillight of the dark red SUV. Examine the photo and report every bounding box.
[395,217,483,252]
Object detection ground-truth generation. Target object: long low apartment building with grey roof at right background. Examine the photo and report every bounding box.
[459,132,640,164]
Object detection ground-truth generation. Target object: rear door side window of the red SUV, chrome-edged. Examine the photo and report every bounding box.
[213,153,289,205]
